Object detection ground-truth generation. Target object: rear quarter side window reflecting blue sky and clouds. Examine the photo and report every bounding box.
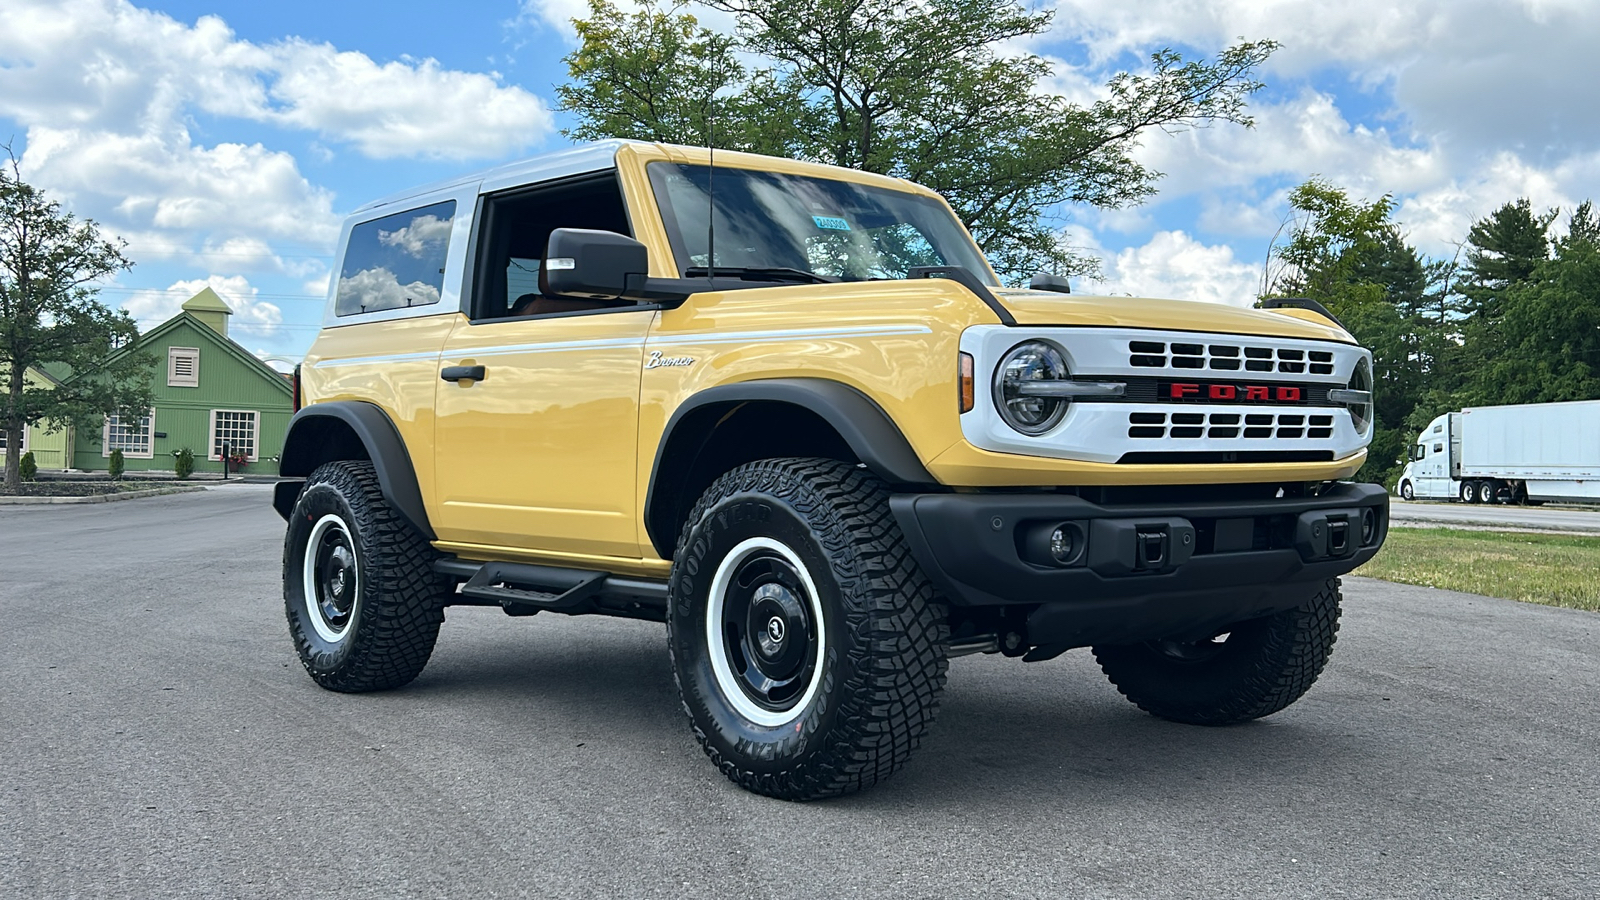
[333,200,456,315]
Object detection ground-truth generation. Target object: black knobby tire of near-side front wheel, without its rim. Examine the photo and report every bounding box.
[667,458,949,801]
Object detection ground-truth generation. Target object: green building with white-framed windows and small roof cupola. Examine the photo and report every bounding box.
[69,288,294,476]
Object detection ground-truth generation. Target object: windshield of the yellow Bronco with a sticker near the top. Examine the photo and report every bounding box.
[648,162,994,283]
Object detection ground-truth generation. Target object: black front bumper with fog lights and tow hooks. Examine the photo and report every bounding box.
[890,484,1389,647]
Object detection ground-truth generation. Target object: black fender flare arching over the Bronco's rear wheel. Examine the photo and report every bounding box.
[272,400,435,541]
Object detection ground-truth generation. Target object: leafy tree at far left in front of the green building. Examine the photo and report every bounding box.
[0,147,150,493]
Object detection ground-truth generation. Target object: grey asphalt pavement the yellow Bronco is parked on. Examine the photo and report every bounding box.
[0,485,1600,900]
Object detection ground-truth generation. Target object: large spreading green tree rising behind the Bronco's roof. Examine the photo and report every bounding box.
[557,0,1278,280]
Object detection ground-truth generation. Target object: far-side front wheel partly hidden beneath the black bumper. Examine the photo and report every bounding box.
[1094,578,1339,725]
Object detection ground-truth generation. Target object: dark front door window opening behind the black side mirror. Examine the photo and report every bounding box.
[472,171,634,319]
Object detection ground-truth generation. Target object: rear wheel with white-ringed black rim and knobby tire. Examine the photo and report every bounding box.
[283,461,445,693]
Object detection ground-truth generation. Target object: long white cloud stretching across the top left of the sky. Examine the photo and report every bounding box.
[0,0,554,159]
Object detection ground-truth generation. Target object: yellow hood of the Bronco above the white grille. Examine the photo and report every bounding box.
[994,288,1355,344]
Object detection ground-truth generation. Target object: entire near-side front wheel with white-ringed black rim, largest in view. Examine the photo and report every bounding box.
[667,460,949,801]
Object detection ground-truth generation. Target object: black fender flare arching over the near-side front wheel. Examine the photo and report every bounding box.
[643,378,939,559]
